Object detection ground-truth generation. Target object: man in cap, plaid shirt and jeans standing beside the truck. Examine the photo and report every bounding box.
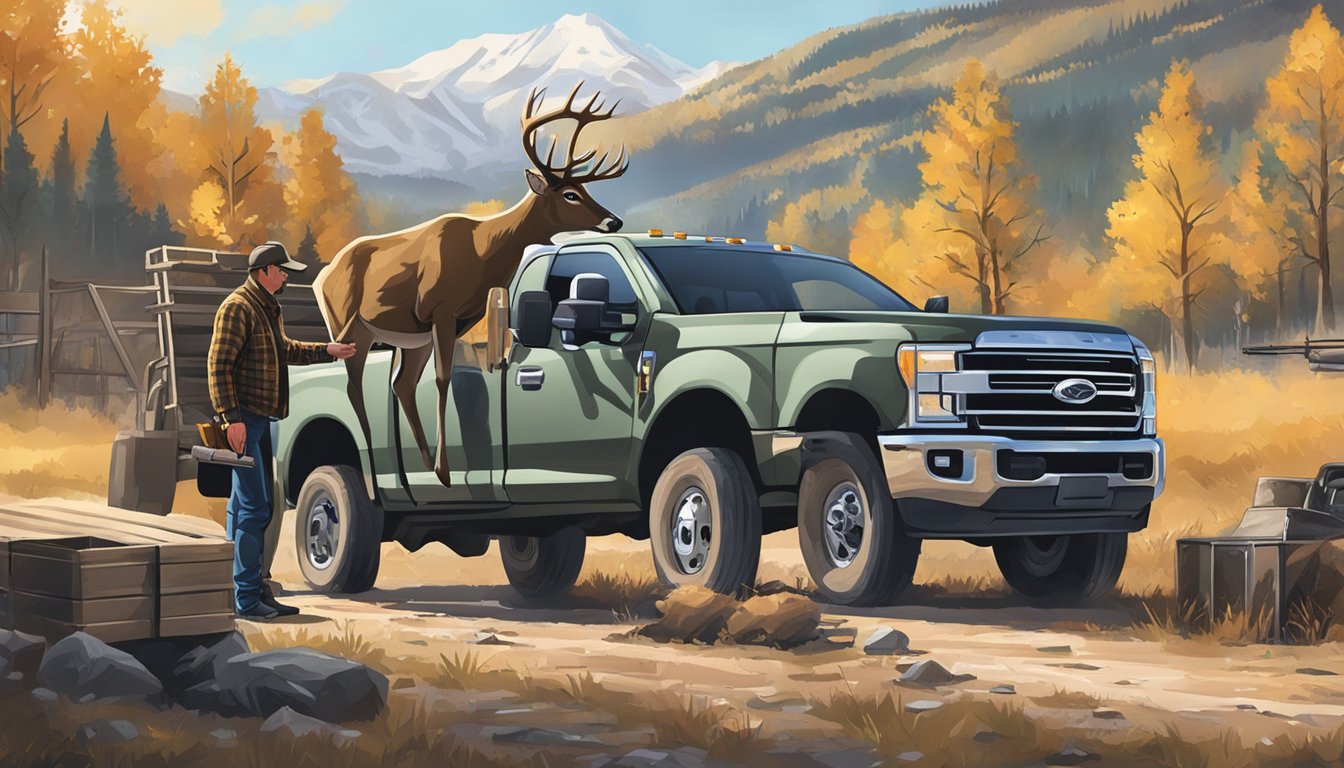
[206,241,355,619]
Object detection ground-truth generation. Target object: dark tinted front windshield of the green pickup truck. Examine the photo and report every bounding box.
[640,245,915,315]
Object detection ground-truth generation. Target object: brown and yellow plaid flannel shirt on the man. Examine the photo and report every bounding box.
[206,277,332,424]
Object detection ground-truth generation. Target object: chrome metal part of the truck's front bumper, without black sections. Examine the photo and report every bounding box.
[878,434,1167,507]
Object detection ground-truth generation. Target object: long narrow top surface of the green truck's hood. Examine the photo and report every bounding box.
[797,311,1129,344]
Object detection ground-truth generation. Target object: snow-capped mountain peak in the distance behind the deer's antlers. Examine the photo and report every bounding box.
[249,13,732,178]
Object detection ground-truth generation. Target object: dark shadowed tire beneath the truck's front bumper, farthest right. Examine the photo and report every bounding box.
[993,533,1129,605]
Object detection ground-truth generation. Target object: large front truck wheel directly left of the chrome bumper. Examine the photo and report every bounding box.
[798,432,923,605]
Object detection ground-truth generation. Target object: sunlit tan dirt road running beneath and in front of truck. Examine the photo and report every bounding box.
[247,521,1344,763]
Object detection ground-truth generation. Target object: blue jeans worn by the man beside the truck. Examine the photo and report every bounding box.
[227,410,270,611]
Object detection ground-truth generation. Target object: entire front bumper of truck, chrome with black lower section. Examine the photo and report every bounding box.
[878,433,1165,538]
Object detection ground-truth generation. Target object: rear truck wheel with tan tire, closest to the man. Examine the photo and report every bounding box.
[294,465,383,594]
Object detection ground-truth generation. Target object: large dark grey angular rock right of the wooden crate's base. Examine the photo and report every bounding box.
[216,648,387,722]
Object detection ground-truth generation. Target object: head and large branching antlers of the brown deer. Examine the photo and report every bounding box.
[523,81,629,233]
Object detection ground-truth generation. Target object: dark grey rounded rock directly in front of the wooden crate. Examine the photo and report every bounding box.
[38,632,164,699]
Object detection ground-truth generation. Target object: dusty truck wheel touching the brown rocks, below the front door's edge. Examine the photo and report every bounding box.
[649,448,761,594]
